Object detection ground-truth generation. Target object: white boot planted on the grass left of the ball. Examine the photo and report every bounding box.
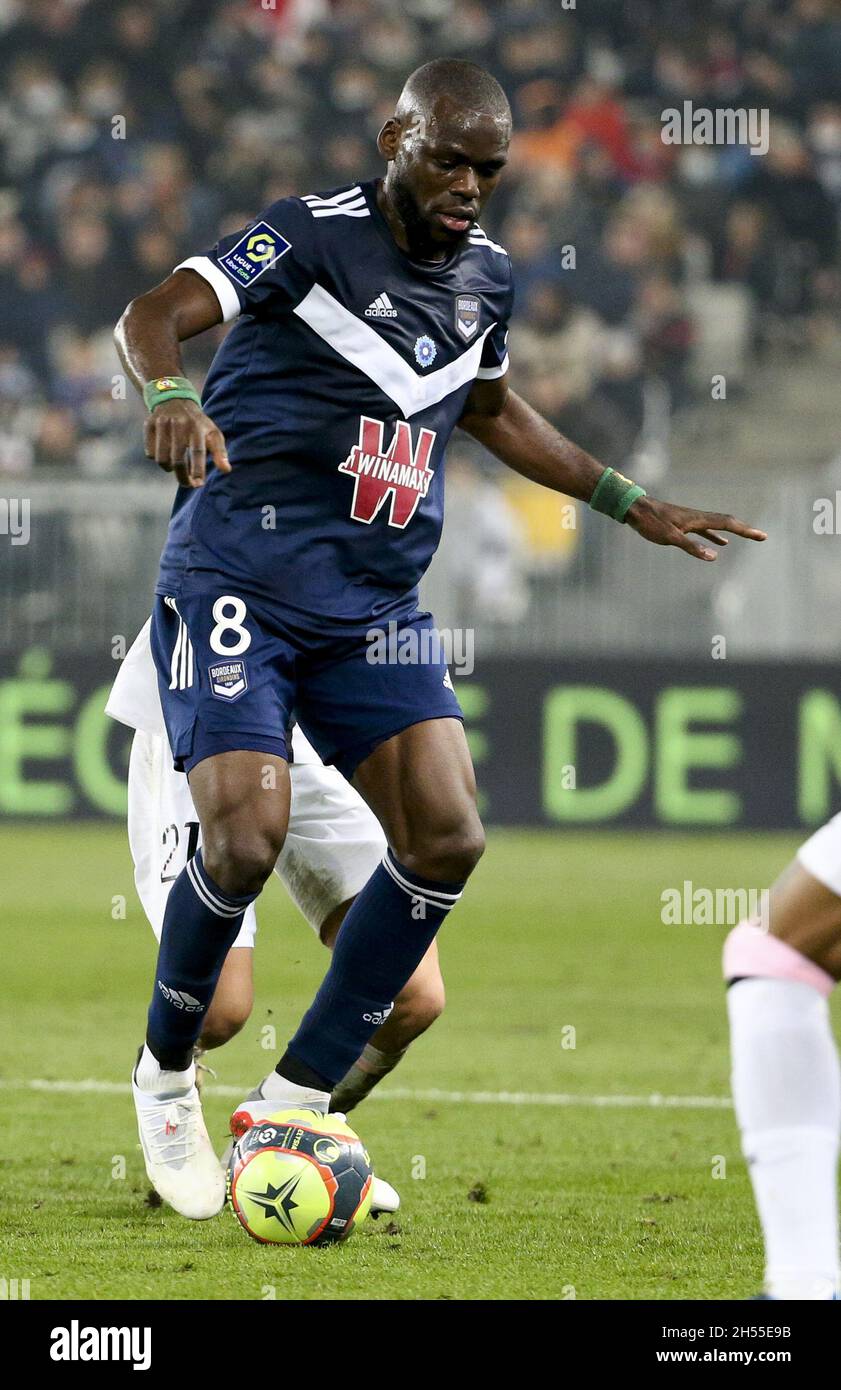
[132,1045,225,1220]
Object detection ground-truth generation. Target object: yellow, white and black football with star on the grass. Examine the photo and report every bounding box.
[228,1109,373,1245]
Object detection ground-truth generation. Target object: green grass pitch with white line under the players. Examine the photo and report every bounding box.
[0,826,811,1300]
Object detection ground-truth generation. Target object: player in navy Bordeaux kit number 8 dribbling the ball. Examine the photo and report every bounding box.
[117,60,763,1216]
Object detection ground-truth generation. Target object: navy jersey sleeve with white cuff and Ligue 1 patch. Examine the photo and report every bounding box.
[175,197,316,324]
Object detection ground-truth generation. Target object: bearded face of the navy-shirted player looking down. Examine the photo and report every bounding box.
[388,102,510,254]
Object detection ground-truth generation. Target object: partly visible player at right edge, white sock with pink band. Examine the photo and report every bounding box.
[724,816,841,1300]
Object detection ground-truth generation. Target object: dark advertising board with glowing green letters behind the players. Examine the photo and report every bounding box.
[0,646,841,830]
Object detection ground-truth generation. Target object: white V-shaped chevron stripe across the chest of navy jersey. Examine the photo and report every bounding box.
[293,285,496,420]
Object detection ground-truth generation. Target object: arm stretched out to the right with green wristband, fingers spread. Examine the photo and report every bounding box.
[459,378,766,560]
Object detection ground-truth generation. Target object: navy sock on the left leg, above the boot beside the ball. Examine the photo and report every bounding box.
[146,849,257,1072]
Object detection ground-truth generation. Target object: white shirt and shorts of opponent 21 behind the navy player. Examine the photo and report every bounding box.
[106,623,385,947]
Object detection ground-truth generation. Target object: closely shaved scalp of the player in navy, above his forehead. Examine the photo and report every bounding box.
[395,58,512,138]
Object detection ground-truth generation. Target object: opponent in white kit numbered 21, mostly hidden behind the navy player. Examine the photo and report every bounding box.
[106,623,443,1112]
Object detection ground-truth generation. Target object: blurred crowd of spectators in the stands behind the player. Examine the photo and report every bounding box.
[0,0,841,511]
